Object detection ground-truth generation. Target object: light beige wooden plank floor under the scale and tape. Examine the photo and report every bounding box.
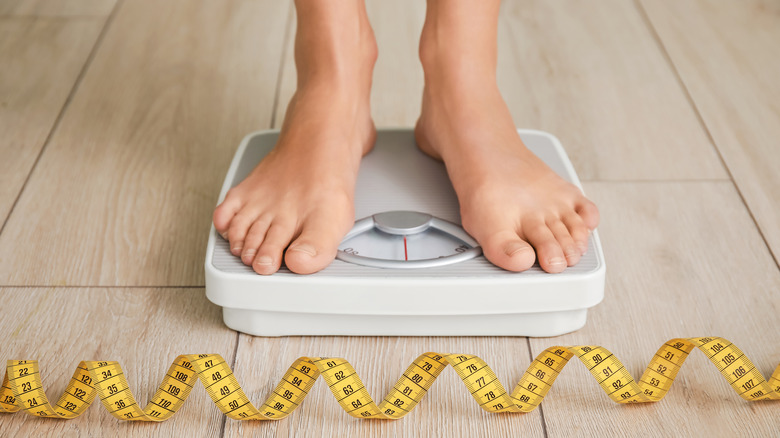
[0,0,780,437]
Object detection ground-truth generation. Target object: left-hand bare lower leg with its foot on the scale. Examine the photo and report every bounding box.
[214,0,377,274]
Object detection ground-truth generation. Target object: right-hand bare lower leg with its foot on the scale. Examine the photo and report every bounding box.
[415,0,599,272]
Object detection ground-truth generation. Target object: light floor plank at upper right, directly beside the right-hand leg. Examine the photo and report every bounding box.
[498,0,727,180]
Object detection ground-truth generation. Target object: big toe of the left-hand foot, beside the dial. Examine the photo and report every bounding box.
[284,215,348,274]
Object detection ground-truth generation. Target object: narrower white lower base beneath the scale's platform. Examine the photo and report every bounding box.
[222,307,588,337]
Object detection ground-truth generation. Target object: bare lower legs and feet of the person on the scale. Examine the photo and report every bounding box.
[214,0,599,274]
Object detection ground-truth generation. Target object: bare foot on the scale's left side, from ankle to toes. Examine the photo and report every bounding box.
[214,89,375,274]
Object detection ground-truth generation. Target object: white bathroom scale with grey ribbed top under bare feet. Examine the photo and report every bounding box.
[205,129,606,336]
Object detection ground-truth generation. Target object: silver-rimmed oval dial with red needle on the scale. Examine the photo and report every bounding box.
[336,211,482,269]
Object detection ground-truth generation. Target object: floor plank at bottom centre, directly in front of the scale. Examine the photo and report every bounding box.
[225,335,543,437]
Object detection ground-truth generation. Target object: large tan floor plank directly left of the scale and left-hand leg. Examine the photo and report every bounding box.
[0,0,288,286]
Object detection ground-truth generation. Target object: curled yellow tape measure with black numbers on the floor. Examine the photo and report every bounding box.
[0,337,780,421]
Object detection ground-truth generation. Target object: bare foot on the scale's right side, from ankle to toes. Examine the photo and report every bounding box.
[415,86,599,273]
